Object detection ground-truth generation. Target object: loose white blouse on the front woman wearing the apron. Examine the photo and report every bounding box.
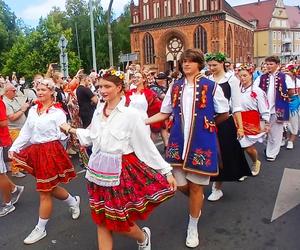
[76,97,172,174]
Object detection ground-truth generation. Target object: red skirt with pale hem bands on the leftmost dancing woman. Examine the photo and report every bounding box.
[13,141,76,192]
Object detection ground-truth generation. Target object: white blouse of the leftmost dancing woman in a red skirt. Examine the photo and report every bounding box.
[9,105,67,153]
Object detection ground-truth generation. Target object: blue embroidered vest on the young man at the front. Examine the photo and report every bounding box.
[166,77,219,176]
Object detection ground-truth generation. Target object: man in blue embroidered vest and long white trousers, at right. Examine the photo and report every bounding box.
[254,56,293,161]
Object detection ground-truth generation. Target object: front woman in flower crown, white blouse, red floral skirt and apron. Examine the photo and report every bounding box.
[62,69,176,250]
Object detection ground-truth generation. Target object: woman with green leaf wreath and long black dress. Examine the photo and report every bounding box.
[205,53,252,201]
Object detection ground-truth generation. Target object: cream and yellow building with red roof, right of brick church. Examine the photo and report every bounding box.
[234,0,300,65]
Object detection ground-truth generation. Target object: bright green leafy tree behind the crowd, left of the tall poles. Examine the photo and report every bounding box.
[3,8,80,78]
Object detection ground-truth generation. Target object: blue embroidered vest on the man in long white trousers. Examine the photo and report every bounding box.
[259,72,289,121]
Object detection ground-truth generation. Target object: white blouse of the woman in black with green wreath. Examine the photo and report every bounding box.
[208,72,242,113]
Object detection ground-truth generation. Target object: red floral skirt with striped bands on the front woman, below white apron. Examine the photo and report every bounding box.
[88,153,174,232]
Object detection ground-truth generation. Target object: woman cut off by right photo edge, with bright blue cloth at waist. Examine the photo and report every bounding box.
[285,64,300,149]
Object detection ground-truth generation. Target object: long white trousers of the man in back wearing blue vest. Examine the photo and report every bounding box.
[266,114,283,158]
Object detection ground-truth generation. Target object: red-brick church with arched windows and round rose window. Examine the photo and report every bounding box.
[130,0,253,71]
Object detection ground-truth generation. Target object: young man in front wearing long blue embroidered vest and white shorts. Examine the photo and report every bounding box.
[146,49,229,247]
